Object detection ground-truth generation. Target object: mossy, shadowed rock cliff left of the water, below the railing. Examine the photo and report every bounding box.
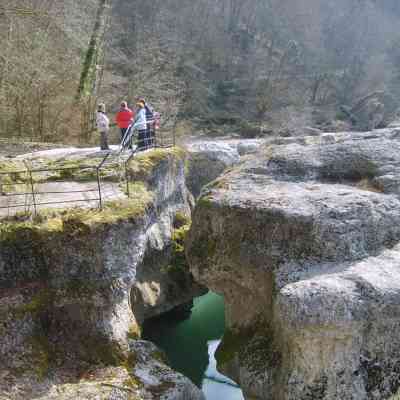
[0,149,204,399]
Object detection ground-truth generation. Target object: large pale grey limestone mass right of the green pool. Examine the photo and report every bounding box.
[187,129,400,400]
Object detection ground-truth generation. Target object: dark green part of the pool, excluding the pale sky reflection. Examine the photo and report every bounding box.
[144,292,225,387]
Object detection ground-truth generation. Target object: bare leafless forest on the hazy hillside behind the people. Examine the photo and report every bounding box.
[0,0,400,143]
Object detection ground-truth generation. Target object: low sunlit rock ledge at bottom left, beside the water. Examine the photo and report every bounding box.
[9,340,204,400]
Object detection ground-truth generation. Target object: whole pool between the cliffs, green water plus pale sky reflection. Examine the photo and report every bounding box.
[144,292,243,400]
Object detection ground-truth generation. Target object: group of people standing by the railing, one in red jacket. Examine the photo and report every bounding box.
[96,99,157,150]
